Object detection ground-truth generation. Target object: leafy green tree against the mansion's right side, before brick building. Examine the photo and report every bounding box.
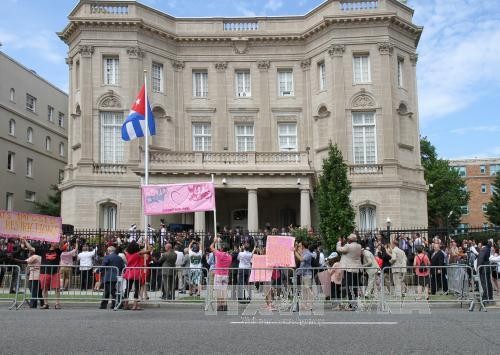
[420,137,469,228]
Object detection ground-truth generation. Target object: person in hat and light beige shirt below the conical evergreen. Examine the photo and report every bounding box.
[337,233,361,309]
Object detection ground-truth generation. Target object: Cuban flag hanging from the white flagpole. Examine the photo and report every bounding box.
[122,85,156,141]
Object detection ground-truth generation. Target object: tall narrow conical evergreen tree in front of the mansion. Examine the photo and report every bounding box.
[315,142,355,249]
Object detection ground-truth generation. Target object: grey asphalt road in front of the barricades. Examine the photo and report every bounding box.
[0,305,500,354]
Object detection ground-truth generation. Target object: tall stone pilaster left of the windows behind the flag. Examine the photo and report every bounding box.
[78,45,94,164]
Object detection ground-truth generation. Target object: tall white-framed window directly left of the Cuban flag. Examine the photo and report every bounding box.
[100,111,124,164]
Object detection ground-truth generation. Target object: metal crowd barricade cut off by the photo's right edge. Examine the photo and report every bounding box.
[476,263,500,311]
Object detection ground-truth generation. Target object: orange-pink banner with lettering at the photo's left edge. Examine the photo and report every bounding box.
[0,210,62,243]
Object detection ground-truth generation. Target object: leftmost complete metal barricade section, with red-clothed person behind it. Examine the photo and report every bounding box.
[17,265,120,309]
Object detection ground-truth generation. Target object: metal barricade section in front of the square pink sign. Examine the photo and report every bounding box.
[205,267,297,316]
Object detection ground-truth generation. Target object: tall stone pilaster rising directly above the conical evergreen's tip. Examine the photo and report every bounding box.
[327,44,351,151]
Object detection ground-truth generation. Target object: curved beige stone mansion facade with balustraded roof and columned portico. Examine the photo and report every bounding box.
[59,0,427,231]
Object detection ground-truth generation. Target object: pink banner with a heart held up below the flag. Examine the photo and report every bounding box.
[142,182,215,215]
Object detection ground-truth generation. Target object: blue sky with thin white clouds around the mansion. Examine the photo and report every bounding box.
[0,0,500,159]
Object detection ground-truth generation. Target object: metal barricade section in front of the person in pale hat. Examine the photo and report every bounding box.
[296,267,381,314]
